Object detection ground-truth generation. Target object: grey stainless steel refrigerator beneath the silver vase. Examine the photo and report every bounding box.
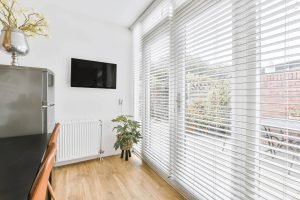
[0,65,55,138]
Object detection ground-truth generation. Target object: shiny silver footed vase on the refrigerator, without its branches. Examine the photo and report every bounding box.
[0,27,29,66]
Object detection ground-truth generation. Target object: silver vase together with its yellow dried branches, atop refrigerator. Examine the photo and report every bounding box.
[0,0,48,65]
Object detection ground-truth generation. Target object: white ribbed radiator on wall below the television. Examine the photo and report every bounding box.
[55,120,104,166]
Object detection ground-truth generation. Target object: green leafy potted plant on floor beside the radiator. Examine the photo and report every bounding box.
[112,115,142,161]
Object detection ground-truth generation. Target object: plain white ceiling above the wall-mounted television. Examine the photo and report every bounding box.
[20,0,153,27]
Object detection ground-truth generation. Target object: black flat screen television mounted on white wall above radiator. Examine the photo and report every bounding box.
[71,58,117,89]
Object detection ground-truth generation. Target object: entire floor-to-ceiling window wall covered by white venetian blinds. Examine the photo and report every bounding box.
[134,0,300,200]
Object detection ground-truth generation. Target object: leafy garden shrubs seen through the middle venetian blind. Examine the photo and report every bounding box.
[186,71,231,137]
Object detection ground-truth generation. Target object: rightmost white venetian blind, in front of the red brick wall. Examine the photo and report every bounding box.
[255,0,300,200]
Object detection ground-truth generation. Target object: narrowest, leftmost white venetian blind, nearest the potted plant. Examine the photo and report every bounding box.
[141,0,171,176]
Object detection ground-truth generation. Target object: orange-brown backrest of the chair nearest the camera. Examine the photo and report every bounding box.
[29,144,56,200]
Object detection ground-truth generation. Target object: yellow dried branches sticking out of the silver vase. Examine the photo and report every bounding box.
[0,0,48,37]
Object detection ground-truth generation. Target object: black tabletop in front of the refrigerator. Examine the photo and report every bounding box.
[0,134,47,200]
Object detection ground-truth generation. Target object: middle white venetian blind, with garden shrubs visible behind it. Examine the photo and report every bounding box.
[172,0,236,199]
